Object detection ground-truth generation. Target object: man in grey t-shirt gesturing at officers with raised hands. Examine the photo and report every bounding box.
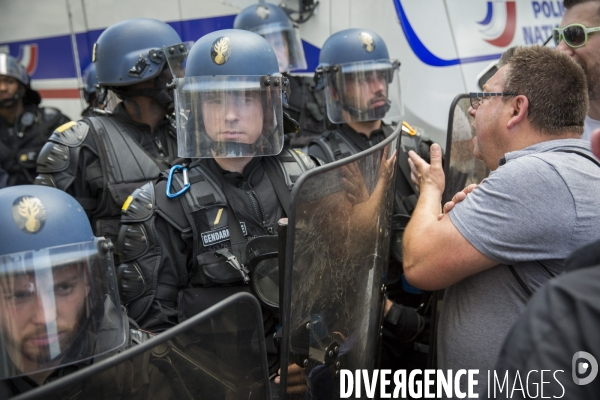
[403,46,600,396]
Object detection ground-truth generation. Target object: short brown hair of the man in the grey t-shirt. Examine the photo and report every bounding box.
[498,46,588,135]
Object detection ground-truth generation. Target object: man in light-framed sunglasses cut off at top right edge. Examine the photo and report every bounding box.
[552,0,600,140]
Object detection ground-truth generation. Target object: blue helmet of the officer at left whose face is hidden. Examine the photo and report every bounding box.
[92,18,181,86]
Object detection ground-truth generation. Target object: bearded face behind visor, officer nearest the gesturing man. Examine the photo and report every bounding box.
[344,70,389,110]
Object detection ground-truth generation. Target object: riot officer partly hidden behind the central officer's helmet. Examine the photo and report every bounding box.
[233,3,328,147]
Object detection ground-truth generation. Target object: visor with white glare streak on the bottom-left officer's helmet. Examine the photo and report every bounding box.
[0,239,125,379]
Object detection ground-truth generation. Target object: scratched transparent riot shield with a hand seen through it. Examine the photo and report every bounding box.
[280,129,400,400]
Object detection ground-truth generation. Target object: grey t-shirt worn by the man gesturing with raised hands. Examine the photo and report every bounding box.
[438,139,600,393]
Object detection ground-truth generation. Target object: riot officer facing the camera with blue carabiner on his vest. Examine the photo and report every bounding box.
[117,29,322,373]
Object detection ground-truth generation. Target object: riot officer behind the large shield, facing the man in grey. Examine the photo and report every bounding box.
[308,29,431,368]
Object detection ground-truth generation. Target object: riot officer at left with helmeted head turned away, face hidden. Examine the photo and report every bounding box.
[36,18,183,250]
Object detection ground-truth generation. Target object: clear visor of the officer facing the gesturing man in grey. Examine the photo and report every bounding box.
[324,60,403,124]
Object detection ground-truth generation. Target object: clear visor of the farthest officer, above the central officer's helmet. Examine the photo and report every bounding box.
[253,22,306,72]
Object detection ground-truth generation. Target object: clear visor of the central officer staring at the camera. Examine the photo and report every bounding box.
[175,76,284,158]
